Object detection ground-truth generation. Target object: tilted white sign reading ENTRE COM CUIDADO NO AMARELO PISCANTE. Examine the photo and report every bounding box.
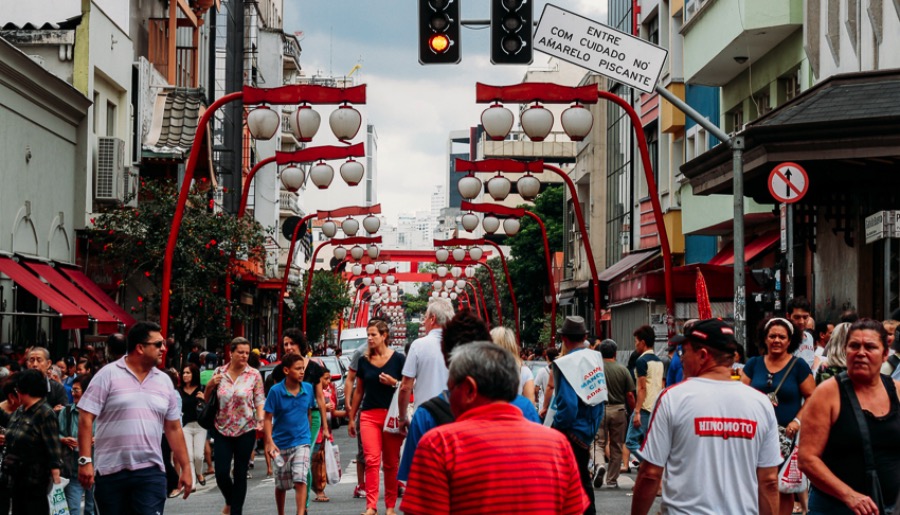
[534,4,668,93]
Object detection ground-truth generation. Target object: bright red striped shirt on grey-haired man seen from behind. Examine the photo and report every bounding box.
[401,403,588,515]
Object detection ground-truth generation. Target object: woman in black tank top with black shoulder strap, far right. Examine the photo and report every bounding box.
[800,319,900,515]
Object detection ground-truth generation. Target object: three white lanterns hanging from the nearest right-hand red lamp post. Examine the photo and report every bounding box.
[481,102,594,141]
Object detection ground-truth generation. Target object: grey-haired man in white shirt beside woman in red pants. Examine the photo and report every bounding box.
[397,298,455,430]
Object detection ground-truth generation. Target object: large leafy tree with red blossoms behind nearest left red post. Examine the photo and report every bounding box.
[91,181,265,343]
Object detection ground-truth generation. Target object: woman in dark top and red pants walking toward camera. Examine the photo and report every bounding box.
[347,320,406,515]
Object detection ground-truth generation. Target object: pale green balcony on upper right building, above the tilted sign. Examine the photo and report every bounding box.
[681,0,803,86]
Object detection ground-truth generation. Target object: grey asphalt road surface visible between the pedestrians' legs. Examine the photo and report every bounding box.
[166,432,659,515]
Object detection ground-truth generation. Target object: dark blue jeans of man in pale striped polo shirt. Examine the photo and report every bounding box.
[94,465,166,515]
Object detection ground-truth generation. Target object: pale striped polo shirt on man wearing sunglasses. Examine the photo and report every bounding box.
[78,358,181,475]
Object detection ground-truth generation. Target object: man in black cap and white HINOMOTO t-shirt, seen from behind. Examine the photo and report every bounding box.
[631,319,782,515]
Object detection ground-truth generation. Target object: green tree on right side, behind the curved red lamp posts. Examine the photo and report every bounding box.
[507,185,564,346]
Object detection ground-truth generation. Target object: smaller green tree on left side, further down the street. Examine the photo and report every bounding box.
[284,270,353,343]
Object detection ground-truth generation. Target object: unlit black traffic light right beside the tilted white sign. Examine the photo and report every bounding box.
[491,0,534,64]
